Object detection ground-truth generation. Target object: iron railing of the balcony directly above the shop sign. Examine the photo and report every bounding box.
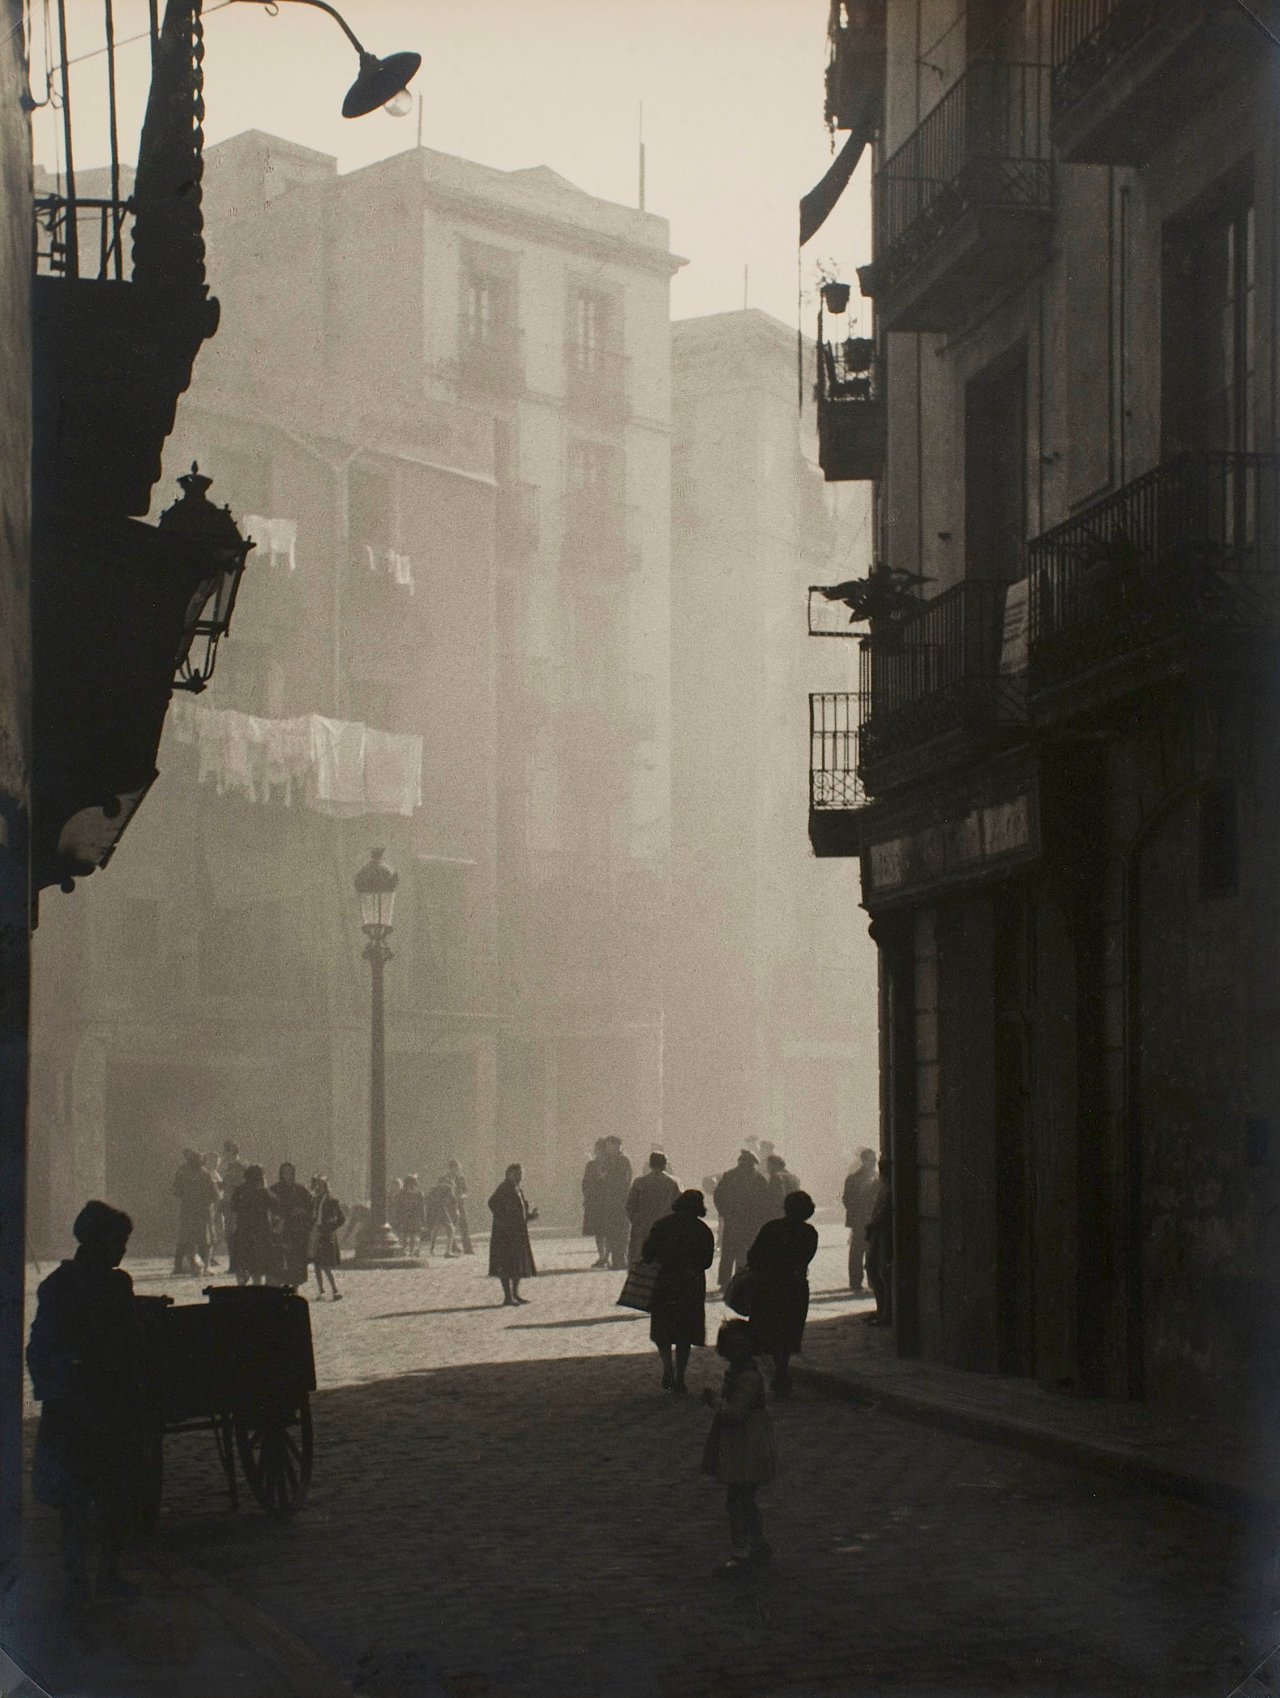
[859,579,1012,761]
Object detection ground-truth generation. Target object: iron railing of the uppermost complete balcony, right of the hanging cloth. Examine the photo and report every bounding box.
[874,59,1053,290]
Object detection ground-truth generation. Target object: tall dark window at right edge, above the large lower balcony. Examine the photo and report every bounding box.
[1161,173,1256,458]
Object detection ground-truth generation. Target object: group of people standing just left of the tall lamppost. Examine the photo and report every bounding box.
[173,1138,346,1302]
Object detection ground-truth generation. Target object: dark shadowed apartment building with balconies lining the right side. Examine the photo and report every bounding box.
[810,0,1280,1411]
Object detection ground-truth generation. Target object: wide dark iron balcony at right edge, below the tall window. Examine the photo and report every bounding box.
[1027,453,1280,720]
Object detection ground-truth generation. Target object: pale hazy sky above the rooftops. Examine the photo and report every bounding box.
[32,0,869,329]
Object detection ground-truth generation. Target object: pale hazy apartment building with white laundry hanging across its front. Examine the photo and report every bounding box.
[32,132,676,1241]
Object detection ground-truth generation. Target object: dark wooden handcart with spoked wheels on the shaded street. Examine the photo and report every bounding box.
[134,1285,316,1520]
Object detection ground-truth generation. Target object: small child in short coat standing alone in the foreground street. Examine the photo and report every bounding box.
[703,1321,778,1574]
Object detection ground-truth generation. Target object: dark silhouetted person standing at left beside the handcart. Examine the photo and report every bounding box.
[27,1202,148,1610]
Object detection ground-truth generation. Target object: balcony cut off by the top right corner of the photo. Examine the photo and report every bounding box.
[1053,0,1268,165]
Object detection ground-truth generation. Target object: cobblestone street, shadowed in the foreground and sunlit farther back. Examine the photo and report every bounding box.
[19,1229,1280,1698]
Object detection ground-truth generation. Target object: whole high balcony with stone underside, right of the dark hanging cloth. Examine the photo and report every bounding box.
[861,59,1053,331]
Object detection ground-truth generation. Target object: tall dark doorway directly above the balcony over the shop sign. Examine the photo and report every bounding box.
[964,350,1027,584]
